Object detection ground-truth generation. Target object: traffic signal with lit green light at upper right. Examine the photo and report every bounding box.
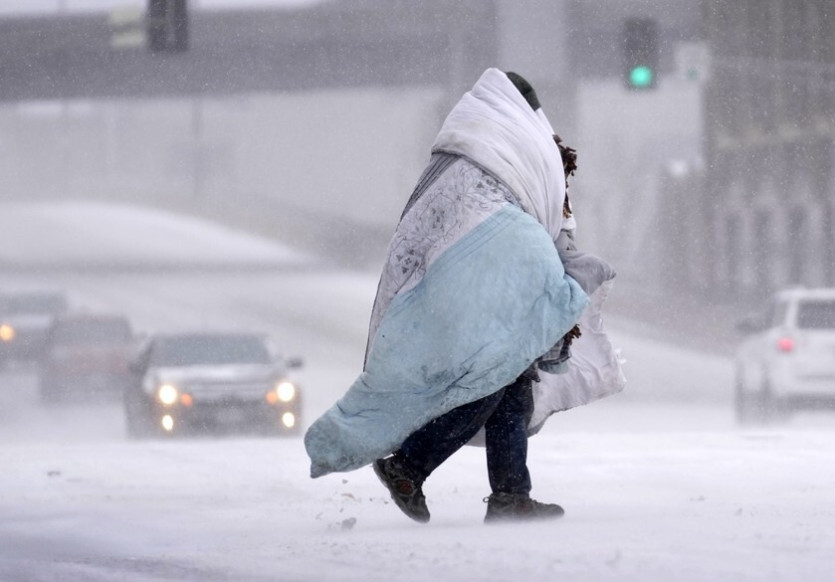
[621,18,658,91]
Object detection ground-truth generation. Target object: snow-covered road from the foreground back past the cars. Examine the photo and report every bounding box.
[0,203,835,582]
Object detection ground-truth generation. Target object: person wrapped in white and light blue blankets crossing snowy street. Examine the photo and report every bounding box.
[305,69,622,522]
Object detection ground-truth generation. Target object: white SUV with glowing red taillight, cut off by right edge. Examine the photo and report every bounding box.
[735,288,835,423]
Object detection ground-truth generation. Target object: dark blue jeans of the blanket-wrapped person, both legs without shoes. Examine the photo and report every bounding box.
[395,377,533,494]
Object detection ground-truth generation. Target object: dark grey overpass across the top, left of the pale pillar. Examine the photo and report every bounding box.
[0,0,497,102]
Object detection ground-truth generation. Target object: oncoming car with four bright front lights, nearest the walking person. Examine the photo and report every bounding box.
[125,333,302,437]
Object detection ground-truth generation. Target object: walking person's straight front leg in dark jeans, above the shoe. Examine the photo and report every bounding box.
[484,376,533,495]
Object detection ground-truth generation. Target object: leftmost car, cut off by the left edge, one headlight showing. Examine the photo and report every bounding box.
[0,291,68,367]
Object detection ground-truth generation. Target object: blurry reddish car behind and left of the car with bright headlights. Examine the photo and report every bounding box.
[40,313,134,403]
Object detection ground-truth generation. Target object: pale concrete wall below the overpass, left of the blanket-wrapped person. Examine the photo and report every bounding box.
[0,88,443,235]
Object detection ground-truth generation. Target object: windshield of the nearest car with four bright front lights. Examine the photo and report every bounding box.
[151,336,270,366]
